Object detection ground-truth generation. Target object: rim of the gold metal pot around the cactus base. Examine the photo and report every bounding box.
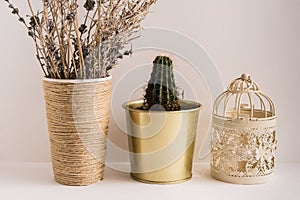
[122,99,203,113]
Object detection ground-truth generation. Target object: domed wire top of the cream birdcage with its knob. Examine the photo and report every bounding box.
[213,74,275,120]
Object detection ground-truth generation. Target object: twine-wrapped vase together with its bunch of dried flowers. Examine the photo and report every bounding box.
[4,0,156,185]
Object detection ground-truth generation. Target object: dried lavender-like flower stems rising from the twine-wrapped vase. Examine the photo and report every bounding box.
[4,0,157,79]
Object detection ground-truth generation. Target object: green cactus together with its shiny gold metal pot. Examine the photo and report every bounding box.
[123,56,201,184]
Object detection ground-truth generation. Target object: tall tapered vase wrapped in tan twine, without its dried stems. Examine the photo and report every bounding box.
[43,77,111,186]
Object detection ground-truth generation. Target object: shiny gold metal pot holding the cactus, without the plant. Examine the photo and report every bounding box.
[123,100,202,184]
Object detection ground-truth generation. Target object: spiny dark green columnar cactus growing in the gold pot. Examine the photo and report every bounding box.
[143,56,180,111]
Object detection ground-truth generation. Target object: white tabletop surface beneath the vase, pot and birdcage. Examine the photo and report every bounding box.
[0,163,300,200]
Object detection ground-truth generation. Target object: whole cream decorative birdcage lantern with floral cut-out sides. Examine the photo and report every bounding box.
[210,74,277,184]
